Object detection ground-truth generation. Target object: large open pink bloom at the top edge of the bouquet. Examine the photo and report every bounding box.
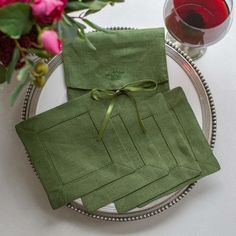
[32,0,67,24]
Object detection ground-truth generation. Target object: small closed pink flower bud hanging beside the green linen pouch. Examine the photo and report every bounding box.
[41,30,62,55]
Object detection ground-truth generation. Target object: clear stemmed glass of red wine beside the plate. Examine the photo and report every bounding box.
[164,0,233,60]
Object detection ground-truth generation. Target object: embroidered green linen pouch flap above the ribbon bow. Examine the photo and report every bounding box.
[62,28,169,99]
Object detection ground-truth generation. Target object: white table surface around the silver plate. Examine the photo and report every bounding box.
[0,0,236,236]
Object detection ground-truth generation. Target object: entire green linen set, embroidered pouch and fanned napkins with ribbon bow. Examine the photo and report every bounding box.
[16,28,220,213]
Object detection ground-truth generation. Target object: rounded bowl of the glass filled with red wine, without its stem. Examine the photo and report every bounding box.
[165,0,230,45]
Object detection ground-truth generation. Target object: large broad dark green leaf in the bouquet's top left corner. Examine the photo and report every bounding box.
[0,3,33,39]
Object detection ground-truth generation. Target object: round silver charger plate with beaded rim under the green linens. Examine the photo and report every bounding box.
[22,27,216,222]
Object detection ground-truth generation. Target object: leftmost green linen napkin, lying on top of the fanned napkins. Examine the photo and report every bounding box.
[16,91,168,208]
